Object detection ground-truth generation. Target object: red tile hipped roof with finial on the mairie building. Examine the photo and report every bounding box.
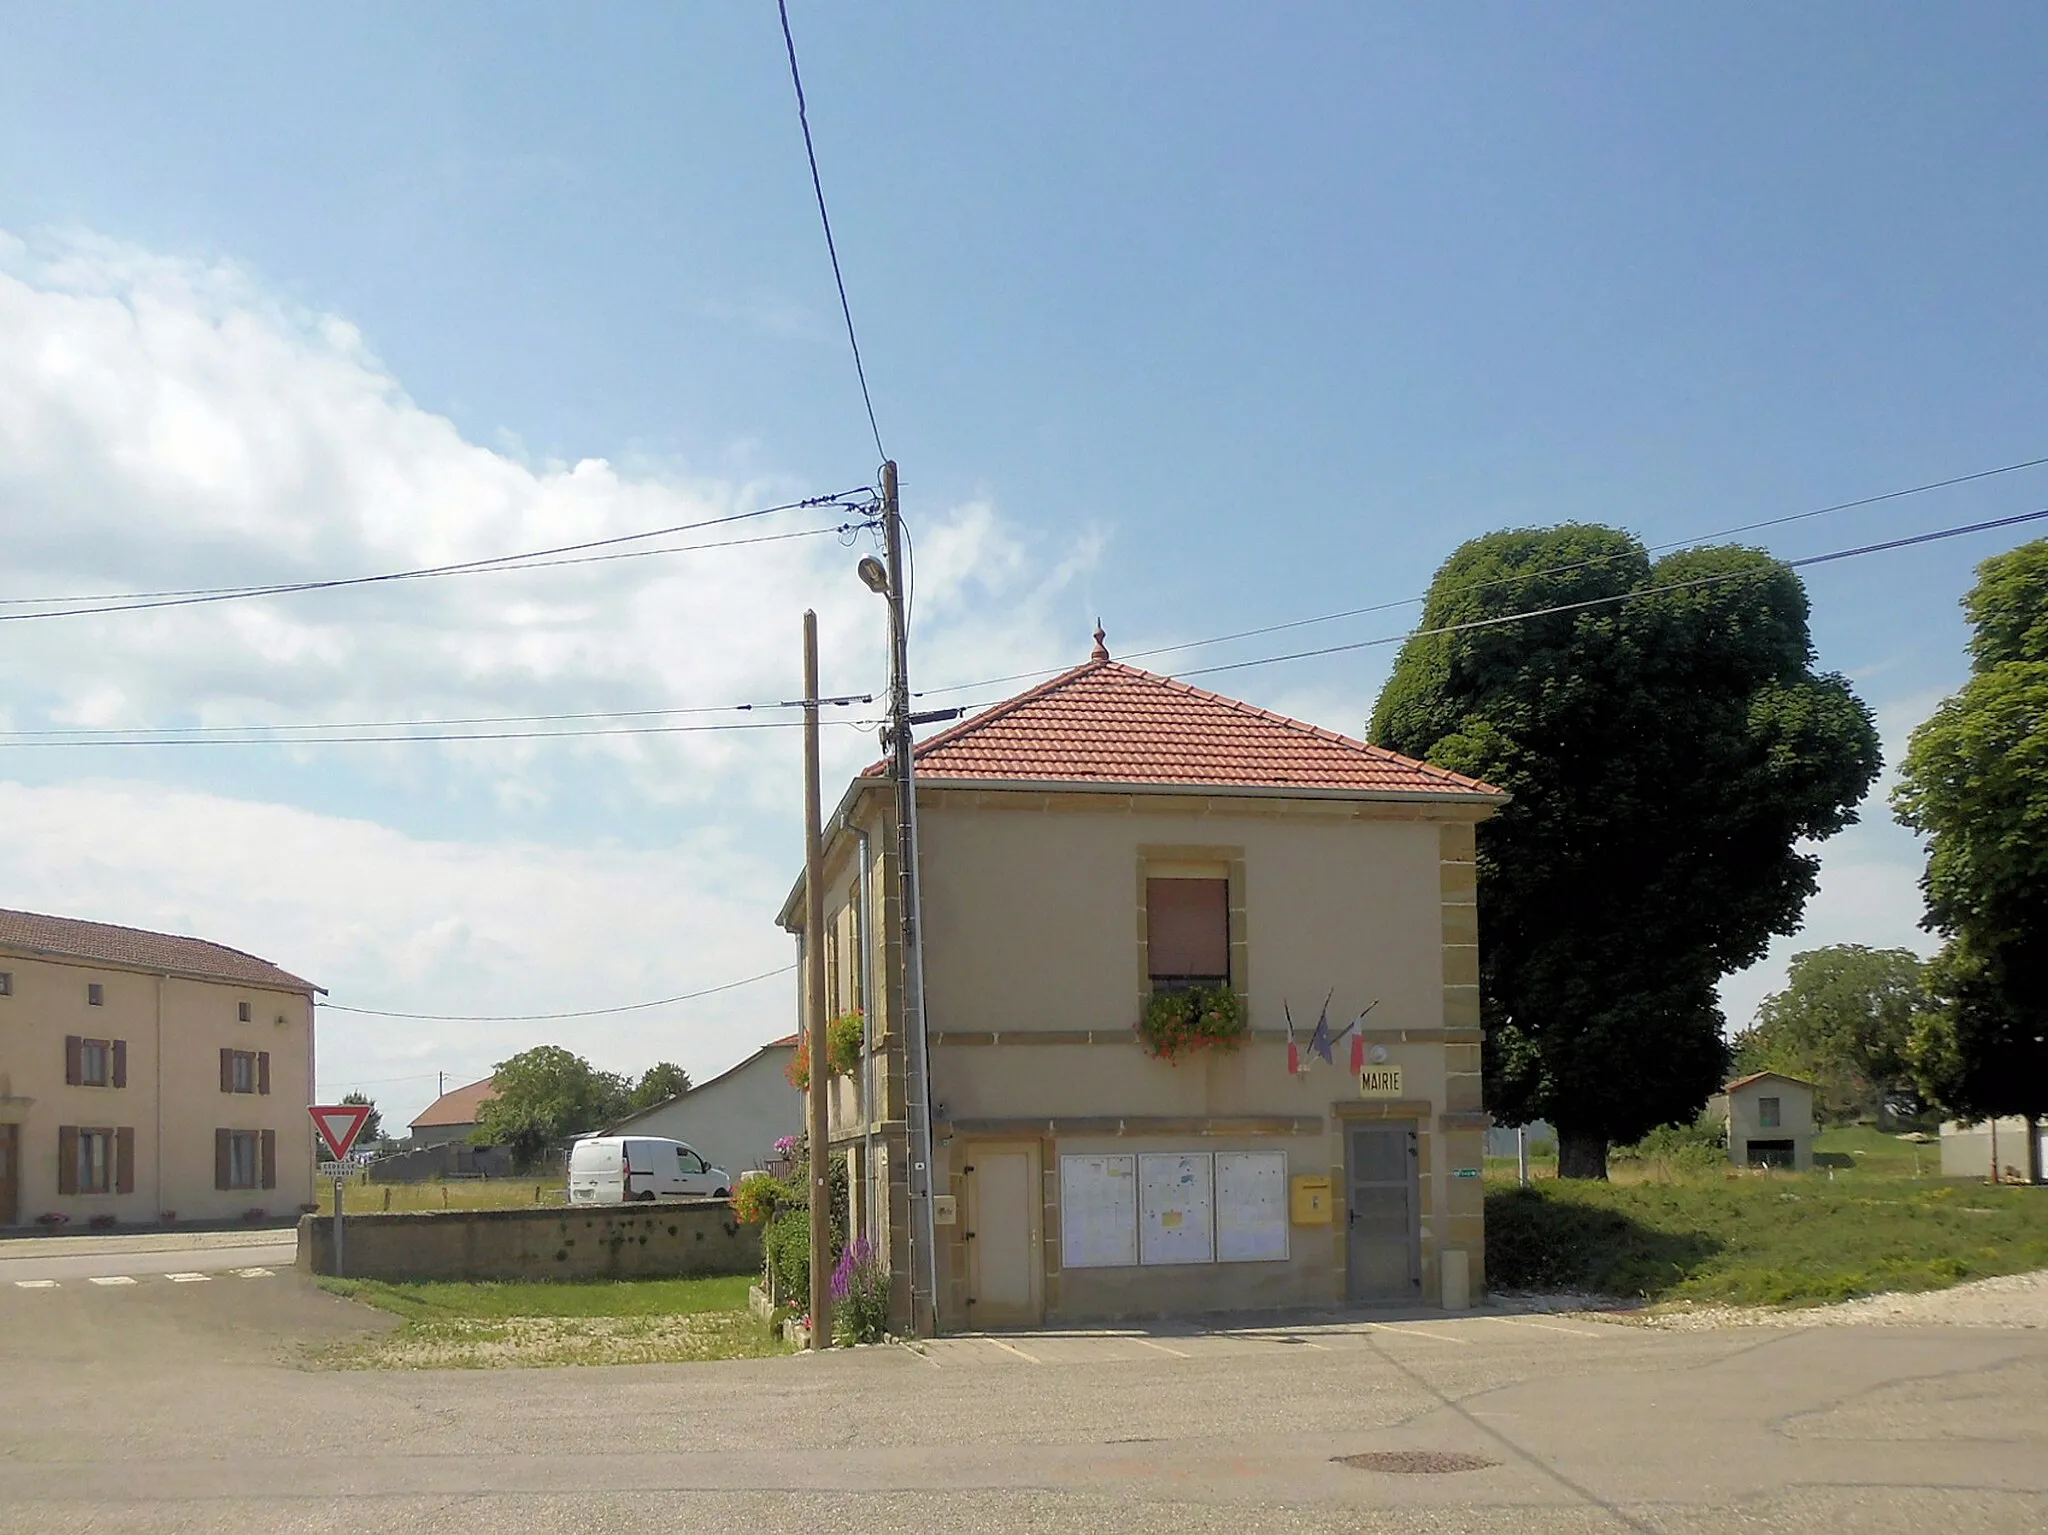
[866,659,1505,798]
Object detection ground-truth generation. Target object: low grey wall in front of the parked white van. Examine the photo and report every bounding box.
[299,1199,762,1279]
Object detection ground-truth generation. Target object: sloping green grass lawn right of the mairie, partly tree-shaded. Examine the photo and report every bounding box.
[1487,1128,2048,1306]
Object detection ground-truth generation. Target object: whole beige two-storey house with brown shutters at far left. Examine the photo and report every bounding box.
[0,911,319,1230]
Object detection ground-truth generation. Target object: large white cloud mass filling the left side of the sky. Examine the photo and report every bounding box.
[0,231,1094,1122]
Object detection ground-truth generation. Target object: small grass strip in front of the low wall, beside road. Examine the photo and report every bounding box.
[317,1275,786,1369]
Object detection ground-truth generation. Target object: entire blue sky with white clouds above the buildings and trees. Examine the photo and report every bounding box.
[0,2,2048,1117]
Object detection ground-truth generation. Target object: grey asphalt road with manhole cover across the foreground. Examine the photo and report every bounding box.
[0,1271,2048,1535]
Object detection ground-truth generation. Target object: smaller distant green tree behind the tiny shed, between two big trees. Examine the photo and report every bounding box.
[1735,944,1927,1124]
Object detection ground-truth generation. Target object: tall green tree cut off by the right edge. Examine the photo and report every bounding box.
[1892,540,2048,1179]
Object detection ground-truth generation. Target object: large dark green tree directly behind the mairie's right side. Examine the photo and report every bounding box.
[1372,524,1878,1177]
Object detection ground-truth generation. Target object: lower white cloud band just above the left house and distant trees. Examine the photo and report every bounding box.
[0,780,795,1122]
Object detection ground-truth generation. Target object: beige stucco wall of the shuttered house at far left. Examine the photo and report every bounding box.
[0,950,313,1230]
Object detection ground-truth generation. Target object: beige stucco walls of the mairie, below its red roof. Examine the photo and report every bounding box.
[786,786,1485,1328]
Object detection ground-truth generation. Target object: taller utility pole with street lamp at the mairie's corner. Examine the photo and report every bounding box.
[881,461,942,1334]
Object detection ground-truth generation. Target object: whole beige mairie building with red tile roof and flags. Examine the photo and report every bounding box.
[782,634,1505,1330]
